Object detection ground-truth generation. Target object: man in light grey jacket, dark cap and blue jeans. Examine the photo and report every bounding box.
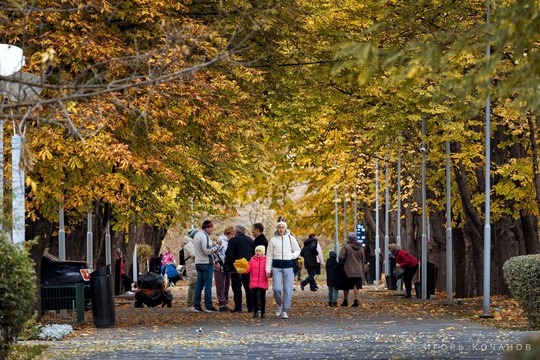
[193,220,221,312]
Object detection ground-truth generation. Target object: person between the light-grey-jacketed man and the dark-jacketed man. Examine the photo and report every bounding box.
[214,226,235,311]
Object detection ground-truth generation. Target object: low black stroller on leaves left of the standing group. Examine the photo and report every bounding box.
[135,273,173,307]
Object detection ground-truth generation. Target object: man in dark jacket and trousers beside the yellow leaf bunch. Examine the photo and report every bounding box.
[225,225,255,312]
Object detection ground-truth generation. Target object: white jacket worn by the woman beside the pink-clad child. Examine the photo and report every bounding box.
[266,229,301,273]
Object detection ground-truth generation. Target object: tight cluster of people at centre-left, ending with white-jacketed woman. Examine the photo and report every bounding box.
[178,220,301,319]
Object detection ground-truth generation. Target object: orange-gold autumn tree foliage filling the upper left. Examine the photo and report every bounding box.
[0,0,271,268]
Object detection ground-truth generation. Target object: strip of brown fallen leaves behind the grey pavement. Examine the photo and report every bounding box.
[45,281,527,335]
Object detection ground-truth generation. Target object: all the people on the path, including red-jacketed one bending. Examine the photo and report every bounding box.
[158,219,418,319]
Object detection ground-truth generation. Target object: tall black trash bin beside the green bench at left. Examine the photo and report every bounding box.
[90,265,116,327]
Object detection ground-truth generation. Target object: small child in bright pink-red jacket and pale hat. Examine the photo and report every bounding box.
[246,245,268,318]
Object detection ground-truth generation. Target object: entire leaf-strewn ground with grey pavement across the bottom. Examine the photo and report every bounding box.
[32,283,540,359]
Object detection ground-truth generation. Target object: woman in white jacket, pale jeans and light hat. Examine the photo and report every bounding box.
[266,219,300,319]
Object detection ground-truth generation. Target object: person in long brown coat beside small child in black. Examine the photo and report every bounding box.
[339,232,365,307]
